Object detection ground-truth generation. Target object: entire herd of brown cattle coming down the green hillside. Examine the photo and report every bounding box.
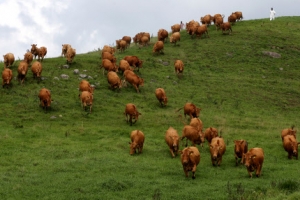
[2,12,300,179]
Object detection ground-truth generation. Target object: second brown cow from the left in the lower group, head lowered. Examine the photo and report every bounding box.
[165,127,179,158]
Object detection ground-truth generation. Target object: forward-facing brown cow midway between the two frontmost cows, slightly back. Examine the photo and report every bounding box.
[210,137,226,166]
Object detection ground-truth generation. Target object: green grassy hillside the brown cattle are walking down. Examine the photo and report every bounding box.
[0,17,300,200]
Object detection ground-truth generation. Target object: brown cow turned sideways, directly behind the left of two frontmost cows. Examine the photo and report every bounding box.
[181,125,205,147]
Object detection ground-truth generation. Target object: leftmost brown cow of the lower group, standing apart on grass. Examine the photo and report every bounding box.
[129,130,145,155]
